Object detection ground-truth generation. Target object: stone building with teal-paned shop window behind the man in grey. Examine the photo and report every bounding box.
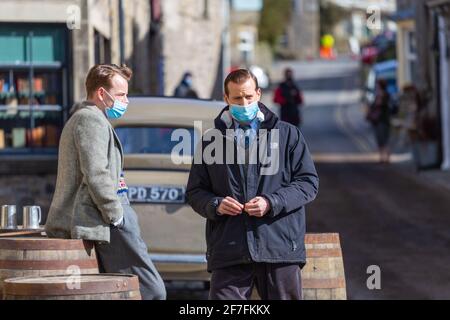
[0,0,152,220]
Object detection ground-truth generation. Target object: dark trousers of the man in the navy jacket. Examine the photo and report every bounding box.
[209,263,302,300]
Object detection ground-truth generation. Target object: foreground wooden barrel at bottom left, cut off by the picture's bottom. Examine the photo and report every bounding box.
[4,273,141,300]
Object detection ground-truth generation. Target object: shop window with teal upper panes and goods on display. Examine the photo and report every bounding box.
[0,24,68,156]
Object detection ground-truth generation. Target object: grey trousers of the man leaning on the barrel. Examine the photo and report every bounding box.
[95,195,166,300]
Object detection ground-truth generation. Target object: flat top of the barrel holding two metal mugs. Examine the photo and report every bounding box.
[0,237,93,250]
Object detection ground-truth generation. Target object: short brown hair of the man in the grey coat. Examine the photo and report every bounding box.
[86,64,133,97]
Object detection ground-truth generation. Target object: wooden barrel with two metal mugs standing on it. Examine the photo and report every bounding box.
[0,238,99,298]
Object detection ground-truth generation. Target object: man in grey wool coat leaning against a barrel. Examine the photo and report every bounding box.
[45,65,166,300]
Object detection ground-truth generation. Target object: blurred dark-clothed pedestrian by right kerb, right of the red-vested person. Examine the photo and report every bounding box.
[367,79,391,163]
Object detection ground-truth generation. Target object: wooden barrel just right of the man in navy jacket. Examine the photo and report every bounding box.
[302,233,347,300]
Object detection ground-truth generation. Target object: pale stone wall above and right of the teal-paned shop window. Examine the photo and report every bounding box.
[0,0,155,101]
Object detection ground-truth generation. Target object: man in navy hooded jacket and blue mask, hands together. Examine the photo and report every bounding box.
[187,69,319,300]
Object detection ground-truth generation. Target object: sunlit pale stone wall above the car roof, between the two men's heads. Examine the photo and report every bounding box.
[162,0,223,98]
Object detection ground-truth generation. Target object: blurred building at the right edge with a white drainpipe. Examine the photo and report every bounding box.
[394,0,450,170]
